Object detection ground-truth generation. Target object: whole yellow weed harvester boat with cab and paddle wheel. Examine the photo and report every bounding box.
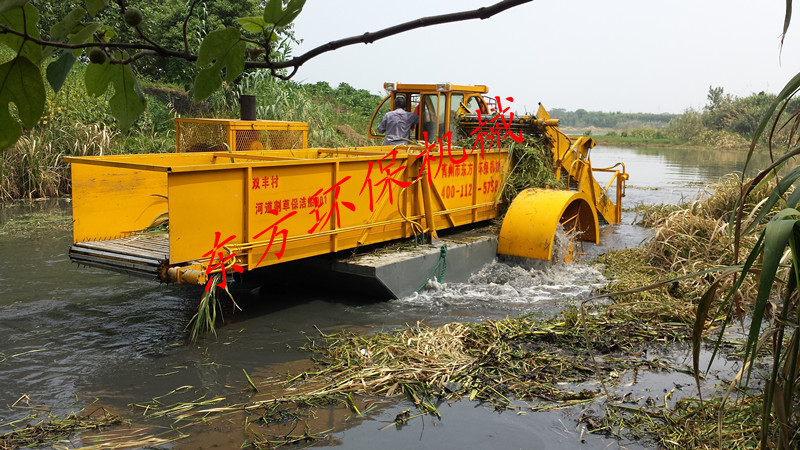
[65,84,627,286]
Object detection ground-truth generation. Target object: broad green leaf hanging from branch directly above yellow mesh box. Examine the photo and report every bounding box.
[194,27,245,102]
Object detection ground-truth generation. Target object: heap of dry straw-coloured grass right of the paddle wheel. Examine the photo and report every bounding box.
[596,174,769,330]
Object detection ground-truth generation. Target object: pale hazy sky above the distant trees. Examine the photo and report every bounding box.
[294,0,800,113]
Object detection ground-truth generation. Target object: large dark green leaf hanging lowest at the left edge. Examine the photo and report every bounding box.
[0,56,45,149]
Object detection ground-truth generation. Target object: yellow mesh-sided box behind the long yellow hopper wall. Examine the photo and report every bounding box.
[175,119,307,153]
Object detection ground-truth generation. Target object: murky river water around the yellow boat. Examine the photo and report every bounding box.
[0,147,776,449]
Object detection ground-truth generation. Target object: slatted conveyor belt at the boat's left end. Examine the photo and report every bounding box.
[69,234,169,278]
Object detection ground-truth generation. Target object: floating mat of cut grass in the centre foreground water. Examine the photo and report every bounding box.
[147,308,690,428]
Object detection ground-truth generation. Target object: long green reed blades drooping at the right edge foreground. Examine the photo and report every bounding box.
[694,147,800,442]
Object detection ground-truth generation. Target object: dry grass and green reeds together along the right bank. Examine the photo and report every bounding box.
[620,157,800,449]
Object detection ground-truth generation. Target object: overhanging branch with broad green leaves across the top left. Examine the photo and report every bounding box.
[0,0,533,150]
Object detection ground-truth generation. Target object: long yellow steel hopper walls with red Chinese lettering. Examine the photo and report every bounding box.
[65,146,508,284]
